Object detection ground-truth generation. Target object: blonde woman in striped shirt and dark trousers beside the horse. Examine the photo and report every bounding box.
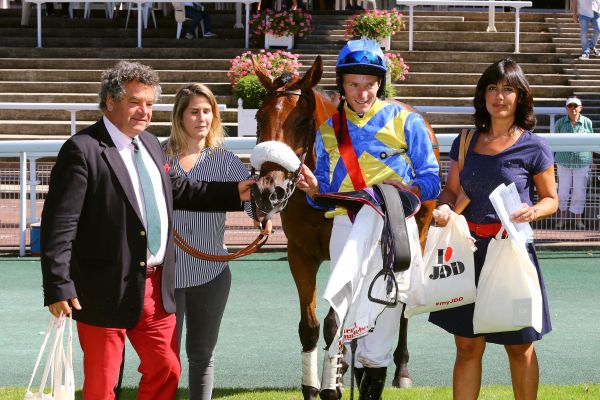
[163,83,249,400]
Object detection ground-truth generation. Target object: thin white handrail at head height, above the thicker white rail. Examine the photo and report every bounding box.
[0,102,565,135]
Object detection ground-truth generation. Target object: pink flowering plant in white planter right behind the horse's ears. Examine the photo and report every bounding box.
[227,50,302,136]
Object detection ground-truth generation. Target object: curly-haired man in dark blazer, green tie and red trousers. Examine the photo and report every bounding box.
[41,62,252,400]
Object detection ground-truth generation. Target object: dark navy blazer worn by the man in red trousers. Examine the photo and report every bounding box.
[40,119,242,328]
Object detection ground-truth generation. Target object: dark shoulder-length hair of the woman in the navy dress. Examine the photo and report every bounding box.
[473,58,537,132]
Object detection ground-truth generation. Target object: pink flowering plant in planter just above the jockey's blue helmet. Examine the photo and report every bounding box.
[346,10,402,50]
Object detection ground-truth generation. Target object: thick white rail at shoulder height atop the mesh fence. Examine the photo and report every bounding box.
[0,133,600,256]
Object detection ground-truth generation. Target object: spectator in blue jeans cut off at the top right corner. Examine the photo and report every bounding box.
[571,0,600,60]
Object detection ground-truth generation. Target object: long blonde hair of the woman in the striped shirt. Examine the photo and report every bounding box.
[166,83,224,157]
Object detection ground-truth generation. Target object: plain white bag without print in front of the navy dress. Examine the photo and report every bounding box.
[473,229,542,333]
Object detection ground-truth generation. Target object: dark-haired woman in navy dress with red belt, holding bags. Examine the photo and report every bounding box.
[429,59,558,400]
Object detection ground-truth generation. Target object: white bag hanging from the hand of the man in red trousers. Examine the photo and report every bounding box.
[25,314,75,400]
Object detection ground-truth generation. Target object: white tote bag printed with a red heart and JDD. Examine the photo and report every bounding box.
[404,213,475,318]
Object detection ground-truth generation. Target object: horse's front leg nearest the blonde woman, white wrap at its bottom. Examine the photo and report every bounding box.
[288,242,320,400]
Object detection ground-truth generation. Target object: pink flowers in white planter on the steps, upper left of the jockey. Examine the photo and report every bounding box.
[250,8,312,50]
